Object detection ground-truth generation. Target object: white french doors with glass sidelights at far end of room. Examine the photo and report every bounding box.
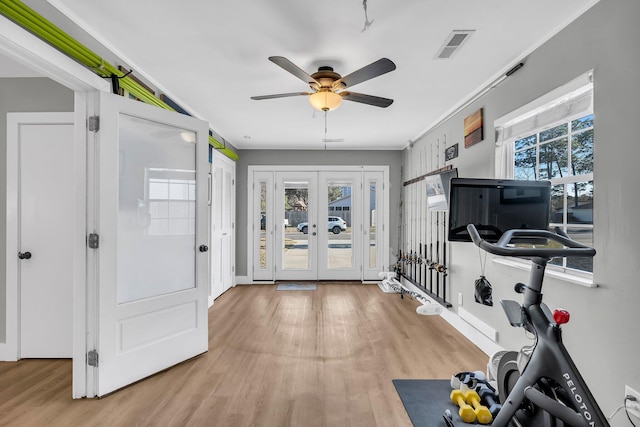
[249,167,388,280]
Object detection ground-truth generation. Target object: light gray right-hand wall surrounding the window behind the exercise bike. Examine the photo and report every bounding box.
[403,0,640,425]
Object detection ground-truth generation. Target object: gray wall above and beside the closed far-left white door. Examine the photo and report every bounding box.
[0,78,73,343]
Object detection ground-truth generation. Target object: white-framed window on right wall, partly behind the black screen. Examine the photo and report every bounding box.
[496,74,594,275]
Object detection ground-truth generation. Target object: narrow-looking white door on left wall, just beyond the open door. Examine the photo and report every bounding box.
[211,152,235,299]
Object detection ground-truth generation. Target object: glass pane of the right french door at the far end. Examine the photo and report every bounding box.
[328,181,353,269]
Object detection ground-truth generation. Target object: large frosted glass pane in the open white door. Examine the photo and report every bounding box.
[117,114,196,304]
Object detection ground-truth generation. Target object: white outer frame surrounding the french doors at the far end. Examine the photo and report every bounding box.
[245,165,390,284]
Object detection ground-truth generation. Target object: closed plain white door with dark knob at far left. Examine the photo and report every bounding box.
[7,113,78,358]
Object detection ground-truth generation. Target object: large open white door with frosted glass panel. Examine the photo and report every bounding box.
[88,93,209,396]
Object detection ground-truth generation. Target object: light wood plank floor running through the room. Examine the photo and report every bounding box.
[0,284,487,427]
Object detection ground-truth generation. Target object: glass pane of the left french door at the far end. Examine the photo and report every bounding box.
[282,181,308,269]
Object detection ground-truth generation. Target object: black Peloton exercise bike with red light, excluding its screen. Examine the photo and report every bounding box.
[467,224,609,427]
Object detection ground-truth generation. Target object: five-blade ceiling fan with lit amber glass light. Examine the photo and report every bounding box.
[251,56,396,111]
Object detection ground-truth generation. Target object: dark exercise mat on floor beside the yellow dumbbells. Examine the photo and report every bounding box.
[393,380,482,427]
